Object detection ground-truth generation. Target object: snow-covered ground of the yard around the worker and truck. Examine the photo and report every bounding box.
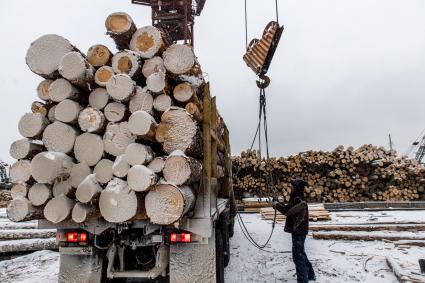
[0,211,425,283]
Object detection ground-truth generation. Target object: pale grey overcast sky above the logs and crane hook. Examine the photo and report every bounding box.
[0,0,425,162]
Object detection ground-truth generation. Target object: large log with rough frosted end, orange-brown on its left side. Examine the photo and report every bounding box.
[156,107,202,156]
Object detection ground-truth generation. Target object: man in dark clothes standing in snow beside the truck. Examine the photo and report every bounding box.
[273,180,316,283]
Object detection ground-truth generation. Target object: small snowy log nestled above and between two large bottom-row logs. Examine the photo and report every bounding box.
[127,165,158,192]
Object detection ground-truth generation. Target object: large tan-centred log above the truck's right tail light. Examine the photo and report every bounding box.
[145,184,195,225]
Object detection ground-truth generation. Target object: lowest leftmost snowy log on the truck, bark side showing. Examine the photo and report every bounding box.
[6,197,43,222]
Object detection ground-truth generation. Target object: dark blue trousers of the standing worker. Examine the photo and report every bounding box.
[292,234,315,283]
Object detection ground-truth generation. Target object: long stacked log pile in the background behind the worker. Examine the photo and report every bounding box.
[233,145,425,202]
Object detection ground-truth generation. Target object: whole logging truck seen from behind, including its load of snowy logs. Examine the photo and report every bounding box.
[7,13,234,282]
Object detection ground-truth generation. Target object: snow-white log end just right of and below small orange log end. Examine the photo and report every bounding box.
[106,74,136,102]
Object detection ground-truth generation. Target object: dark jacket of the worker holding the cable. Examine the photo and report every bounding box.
[276,196,308,235]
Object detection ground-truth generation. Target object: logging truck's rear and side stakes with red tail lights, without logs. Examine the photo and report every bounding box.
[39,85,235,283]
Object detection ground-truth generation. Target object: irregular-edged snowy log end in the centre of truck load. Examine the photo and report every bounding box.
[103,122,136,156]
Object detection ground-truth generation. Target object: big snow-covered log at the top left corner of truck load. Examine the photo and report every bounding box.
[26,34,75,79]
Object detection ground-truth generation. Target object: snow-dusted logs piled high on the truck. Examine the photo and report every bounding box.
[7,13,221,225]
